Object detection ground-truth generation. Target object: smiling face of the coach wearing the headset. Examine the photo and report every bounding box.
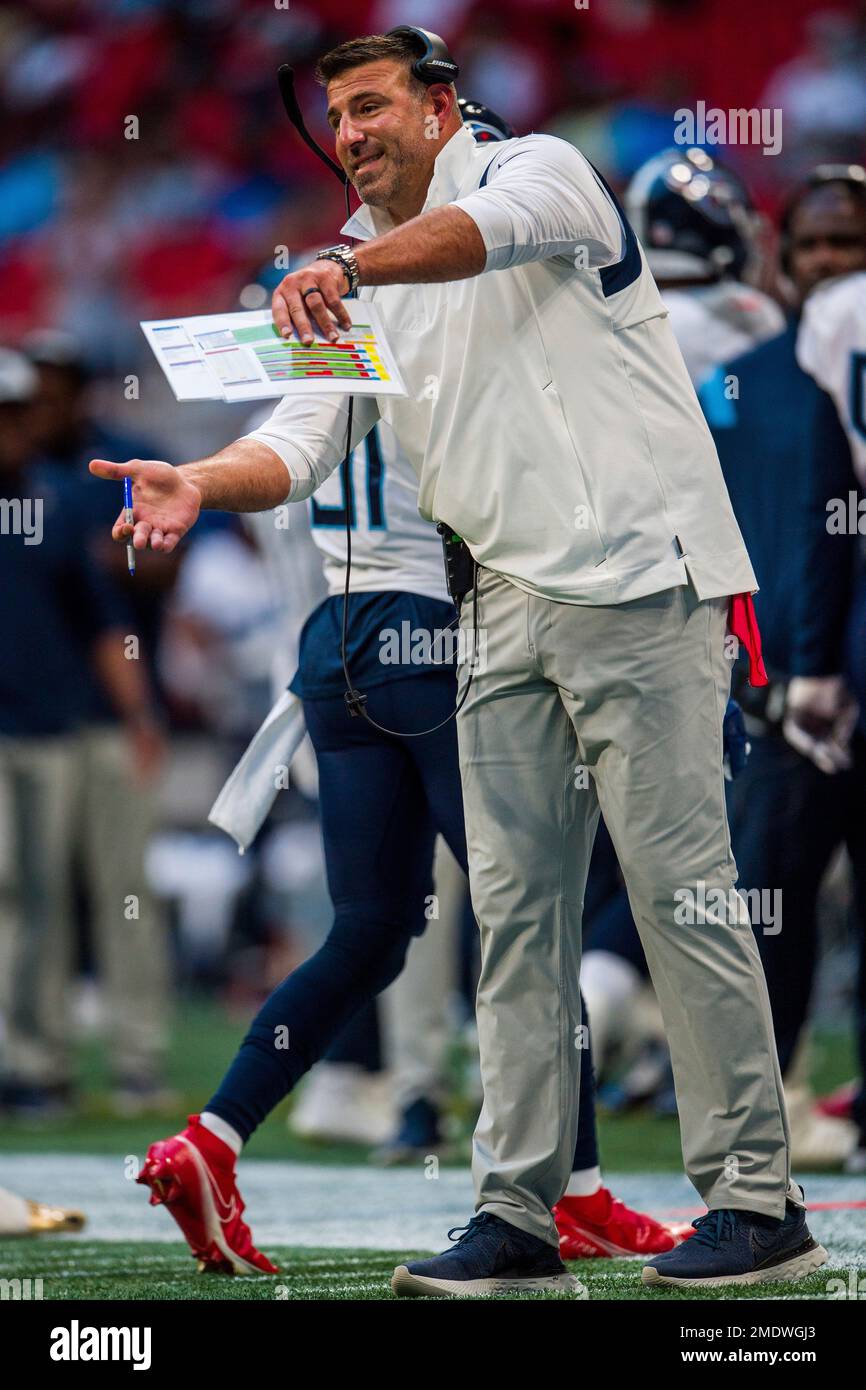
[328,58,460,220]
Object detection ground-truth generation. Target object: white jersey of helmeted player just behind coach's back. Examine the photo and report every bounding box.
[662,279,785,386]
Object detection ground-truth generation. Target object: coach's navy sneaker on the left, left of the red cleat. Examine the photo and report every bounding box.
[391,1212,585,1298]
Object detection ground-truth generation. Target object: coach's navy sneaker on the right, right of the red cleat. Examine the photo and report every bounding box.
[641,1201,827,1289]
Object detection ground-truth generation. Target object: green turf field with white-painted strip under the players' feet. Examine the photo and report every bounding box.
[0,999,866,1301]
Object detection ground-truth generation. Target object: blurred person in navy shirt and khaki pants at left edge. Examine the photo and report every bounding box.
[0,350,165,1118]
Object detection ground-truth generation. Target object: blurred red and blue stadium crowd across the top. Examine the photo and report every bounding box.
[0,0,866,364]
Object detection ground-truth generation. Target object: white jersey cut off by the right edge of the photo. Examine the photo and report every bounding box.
[796,272,866,487]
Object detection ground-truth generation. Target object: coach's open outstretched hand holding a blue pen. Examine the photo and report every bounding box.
[90,459,202,553]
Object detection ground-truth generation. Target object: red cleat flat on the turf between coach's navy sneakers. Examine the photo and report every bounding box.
[553,1187,694,1259]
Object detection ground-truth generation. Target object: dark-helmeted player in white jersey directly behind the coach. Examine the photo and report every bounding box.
[581,149,784,1089]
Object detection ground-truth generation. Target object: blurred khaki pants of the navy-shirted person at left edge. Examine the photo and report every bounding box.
[0,726,168,1086]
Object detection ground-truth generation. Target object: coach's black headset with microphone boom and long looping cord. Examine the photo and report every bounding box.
[277,25,480,738]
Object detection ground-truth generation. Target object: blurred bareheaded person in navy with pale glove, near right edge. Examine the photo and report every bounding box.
[701,159,866,1166]
